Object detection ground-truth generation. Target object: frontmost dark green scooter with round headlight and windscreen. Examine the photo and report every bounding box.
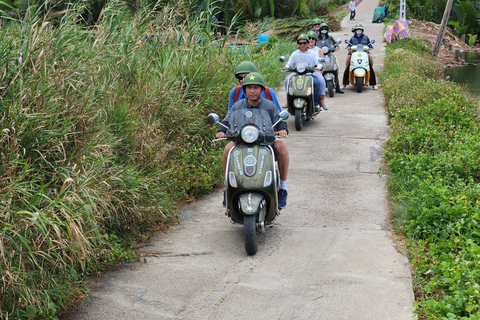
[207,109,289,255]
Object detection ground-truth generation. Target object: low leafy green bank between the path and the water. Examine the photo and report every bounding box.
[381,39,480,319]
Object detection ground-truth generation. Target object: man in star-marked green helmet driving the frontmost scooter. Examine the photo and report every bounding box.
[215,72,290,209]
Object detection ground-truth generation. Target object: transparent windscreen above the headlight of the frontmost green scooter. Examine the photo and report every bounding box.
[229,108,275,143]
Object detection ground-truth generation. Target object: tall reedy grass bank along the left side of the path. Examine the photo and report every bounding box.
[0,2,294,319]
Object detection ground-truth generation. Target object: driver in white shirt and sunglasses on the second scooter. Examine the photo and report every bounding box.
[283,33,329,111]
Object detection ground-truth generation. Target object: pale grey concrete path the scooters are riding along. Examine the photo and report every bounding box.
[64,0,415,320]
